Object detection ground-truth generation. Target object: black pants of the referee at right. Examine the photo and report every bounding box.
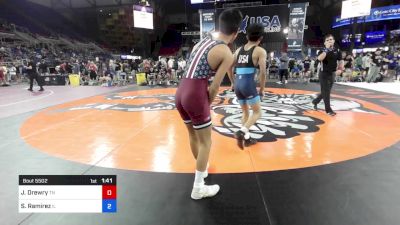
[313,72,335,113]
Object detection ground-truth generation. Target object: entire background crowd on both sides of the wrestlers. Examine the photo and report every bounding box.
[0,17,400,86]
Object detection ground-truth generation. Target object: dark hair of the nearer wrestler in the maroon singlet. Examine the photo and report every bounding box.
[219,9,243,35]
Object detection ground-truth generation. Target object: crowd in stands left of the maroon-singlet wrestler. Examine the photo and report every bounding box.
[0,16,194,86]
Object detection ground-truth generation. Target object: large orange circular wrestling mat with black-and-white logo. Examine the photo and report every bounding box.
[20,88,400,173]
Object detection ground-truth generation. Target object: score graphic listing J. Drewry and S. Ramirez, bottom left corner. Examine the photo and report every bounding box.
[18,175,117,213]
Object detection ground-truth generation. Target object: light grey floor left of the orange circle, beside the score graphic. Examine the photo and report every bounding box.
[0,112,90,225]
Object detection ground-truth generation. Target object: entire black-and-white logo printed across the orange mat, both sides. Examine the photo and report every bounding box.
[58,91,381,142]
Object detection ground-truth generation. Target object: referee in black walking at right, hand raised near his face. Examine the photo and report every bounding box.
[312,34,343,116]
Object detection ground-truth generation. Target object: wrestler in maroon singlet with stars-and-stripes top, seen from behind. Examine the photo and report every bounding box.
[175,9,242,200]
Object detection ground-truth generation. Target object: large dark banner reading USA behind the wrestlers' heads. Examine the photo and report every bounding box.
[217,4,289,46]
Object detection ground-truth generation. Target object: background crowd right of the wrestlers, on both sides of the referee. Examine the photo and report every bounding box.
[268,48,400,84]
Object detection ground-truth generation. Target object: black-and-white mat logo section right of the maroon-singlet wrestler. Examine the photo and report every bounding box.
[212,92,380,142]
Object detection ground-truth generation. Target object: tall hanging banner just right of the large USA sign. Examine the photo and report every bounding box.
[287,2,308,51]
